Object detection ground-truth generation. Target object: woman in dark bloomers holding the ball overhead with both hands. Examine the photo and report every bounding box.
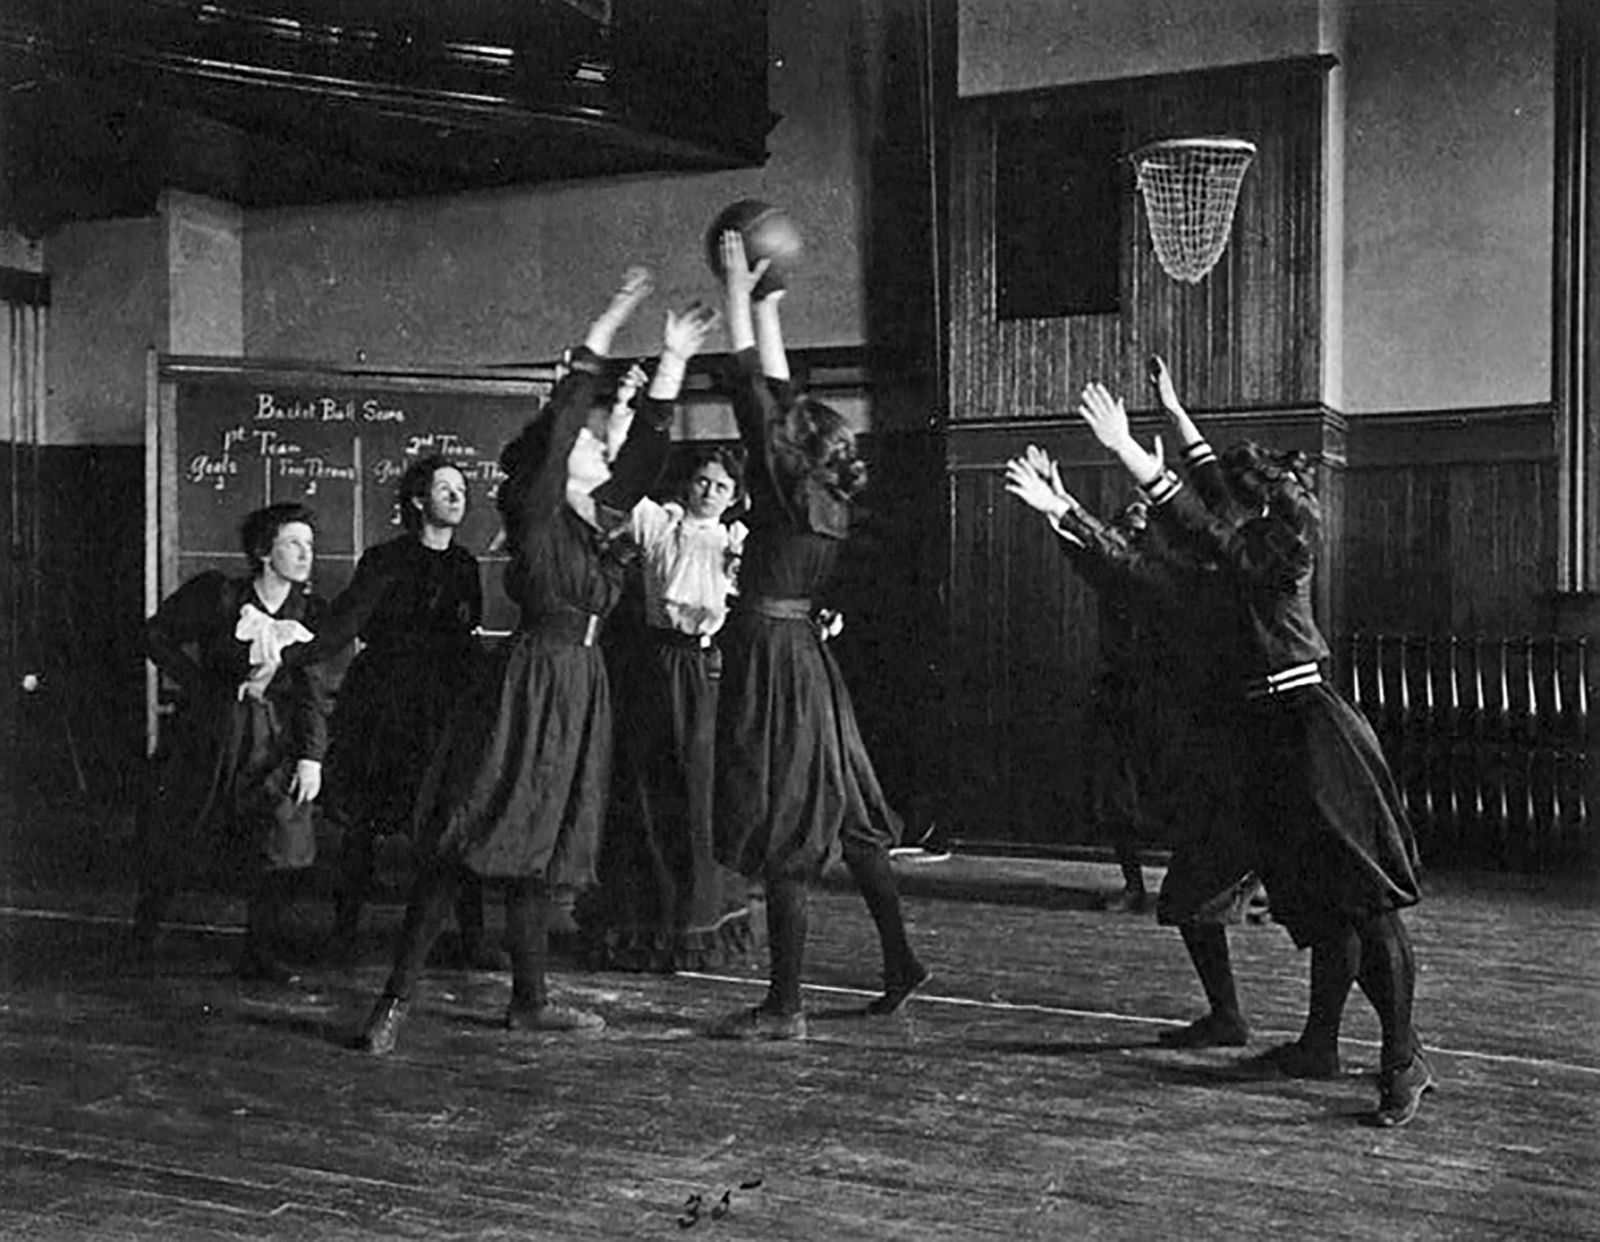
[712,232,930,1039]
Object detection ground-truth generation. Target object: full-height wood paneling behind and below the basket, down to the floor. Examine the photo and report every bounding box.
[947,58,1344,843]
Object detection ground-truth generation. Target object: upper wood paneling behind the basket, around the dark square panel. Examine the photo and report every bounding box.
[950,59,1328,423]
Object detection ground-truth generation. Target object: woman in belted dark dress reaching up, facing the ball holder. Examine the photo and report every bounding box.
[362,269,715,1055]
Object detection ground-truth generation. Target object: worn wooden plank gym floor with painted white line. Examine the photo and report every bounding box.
[0,800,1600,1242]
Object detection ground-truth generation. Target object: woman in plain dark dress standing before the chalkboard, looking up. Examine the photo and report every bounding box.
[285,456,506,970]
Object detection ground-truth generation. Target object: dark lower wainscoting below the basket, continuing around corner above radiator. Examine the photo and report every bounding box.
[947,407,1557,861]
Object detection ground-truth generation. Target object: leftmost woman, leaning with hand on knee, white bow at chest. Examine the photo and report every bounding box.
[133,504,328,983]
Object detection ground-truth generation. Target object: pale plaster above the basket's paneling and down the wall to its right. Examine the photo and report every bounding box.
[958,0,1555,415]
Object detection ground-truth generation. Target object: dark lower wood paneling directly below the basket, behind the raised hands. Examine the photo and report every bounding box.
[946,407,1346,845]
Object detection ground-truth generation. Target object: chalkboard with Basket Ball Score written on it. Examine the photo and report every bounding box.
[147,355,554,646]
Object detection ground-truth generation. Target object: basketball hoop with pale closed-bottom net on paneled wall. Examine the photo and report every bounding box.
[1128,138,1256,285]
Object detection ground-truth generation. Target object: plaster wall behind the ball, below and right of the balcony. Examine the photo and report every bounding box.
[245,0,864,365]
